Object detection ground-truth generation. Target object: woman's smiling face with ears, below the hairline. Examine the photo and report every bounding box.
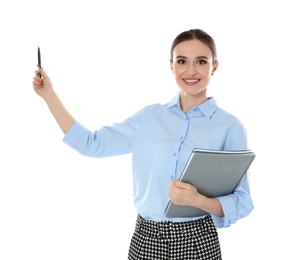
[171,39,218,102]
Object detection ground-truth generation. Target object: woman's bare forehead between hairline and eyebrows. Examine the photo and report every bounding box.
[173,39,212,58]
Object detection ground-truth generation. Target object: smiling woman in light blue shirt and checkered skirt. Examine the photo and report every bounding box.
[33,29,253,260]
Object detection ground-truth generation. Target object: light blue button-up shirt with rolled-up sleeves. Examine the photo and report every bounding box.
[63,92,253,228]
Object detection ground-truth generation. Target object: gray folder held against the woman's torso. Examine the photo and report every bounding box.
[165,148,255,218]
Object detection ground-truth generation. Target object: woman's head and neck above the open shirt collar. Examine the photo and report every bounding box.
[170,30,218,113]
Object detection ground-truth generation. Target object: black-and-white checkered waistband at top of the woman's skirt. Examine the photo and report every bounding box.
[135,215,217,240]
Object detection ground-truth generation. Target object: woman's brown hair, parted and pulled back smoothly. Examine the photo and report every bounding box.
[170,29,217,63]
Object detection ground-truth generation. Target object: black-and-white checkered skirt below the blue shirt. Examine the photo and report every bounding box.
[128,215,222,260]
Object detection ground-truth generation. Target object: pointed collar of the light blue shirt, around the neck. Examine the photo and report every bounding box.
[167,91,218,118]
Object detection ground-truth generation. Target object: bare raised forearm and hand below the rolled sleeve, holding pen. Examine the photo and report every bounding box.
[33,68,75,134]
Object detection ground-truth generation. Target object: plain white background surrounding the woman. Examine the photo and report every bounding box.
[0,0,293,260]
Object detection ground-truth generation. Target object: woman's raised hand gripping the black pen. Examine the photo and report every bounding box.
[33,68,54,100]
